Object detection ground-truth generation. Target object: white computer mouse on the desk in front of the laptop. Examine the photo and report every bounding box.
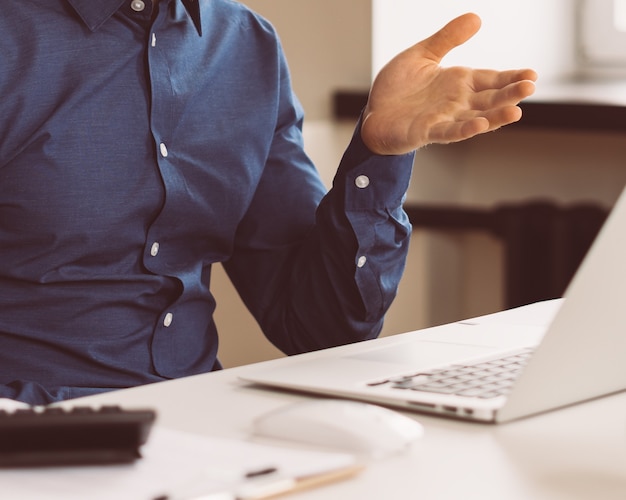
[252,399,424,458]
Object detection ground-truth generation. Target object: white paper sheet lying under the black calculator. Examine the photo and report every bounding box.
[0,427,356,500]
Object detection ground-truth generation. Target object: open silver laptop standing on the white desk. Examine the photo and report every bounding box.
[241,185,626,423]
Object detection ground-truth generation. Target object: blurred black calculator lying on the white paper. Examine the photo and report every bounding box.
[0,406,156,468]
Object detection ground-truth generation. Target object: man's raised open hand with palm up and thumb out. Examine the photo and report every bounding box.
[361,14,537,155]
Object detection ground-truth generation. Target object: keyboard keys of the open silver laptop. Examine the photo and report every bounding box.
[367,349,532,399]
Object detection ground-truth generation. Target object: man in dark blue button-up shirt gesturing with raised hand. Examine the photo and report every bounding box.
[0,0,535,404]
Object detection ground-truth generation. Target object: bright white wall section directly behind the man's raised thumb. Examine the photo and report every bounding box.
[372,0,575,81]
